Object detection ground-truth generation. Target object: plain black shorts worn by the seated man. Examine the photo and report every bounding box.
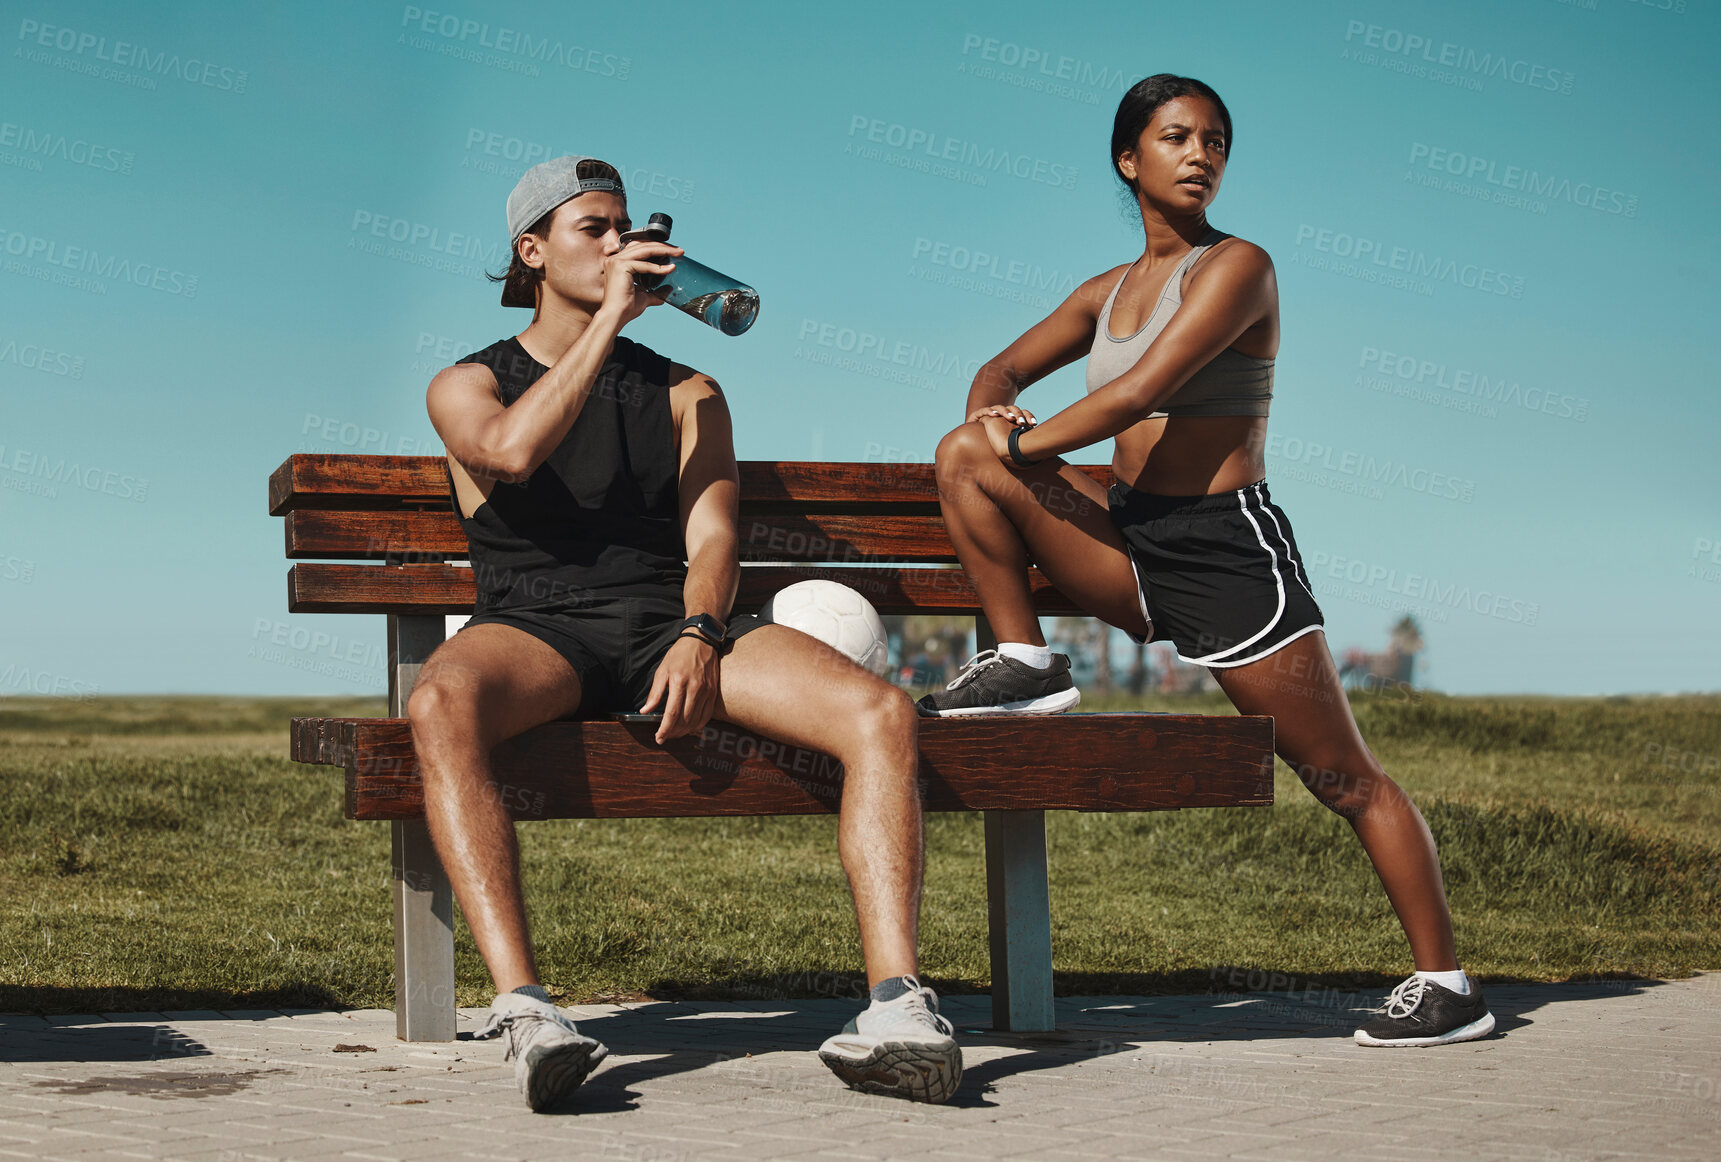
[461,590,764,718]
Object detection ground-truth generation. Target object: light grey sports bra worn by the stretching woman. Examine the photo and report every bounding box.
[1088,227,1274,418]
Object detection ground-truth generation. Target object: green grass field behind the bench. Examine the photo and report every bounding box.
[0,695,1721,1012]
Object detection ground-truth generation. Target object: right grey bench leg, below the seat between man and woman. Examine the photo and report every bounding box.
[983,811,1057,1033]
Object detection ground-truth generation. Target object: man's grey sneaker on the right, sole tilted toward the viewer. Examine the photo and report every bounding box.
[819,976,962,1102]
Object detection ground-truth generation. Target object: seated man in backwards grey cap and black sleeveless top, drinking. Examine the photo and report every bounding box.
[408,157,962,1110]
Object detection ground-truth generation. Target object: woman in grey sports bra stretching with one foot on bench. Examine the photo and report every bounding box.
[921,74,1494,1045]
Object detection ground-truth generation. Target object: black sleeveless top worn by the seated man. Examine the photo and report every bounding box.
[449,337,687,613]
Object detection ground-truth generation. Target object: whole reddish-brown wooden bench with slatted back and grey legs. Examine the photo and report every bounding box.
[268,454,1274,1041]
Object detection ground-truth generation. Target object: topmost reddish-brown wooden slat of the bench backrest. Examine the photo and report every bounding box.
[268,453,1112,516]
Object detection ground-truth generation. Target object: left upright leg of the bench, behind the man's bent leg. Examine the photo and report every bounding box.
[389,615,454,1041]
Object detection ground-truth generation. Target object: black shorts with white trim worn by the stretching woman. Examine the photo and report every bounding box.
[1107,480,1323,668]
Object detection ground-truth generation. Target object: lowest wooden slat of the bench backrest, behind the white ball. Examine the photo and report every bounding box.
[287,563,1081,615]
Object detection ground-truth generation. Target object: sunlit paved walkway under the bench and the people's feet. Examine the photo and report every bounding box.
[0,973,1721,1162]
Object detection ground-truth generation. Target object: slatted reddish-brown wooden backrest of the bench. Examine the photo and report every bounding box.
[268,453,1112,615]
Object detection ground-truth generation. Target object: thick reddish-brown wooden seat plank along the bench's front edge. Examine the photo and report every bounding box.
[294,714,1274,819]
